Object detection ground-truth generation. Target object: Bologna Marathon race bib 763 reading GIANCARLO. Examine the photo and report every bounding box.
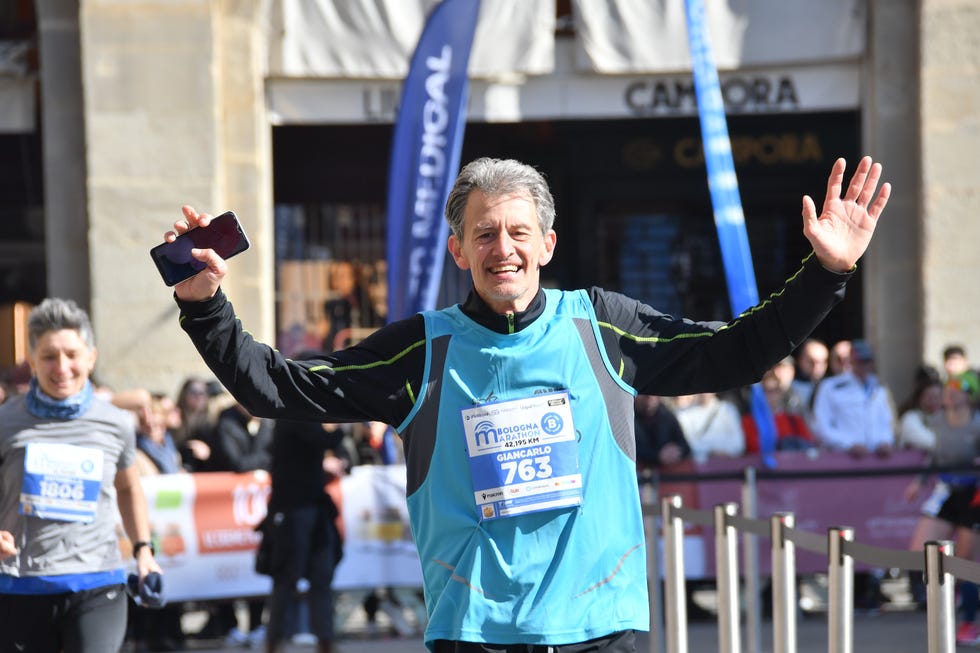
[462,392,582,519]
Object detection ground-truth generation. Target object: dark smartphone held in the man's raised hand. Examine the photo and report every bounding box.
[150,211,249,286]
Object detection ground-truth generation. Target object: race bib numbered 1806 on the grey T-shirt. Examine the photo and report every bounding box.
[20,442,103,523]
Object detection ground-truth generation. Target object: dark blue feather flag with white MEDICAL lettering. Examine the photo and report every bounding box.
[387,0,480,322]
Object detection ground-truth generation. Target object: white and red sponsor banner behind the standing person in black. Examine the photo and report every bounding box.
[126,465,422,601]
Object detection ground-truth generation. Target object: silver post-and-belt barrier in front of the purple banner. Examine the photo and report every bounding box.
[641,460,980,653]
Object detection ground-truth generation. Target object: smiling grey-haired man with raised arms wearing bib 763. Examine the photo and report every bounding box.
[165,157,890,653]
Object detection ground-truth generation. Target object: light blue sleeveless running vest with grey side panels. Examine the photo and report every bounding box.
[398,290,649,647]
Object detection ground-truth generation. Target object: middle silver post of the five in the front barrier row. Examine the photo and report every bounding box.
[769,512,796,653]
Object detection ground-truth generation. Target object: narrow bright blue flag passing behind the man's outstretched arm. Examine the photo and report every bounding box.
[684,0,776,466]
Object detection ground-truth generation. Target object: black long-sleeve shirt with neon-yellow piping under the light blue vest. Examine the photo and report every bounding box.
[178,253,850,438]
